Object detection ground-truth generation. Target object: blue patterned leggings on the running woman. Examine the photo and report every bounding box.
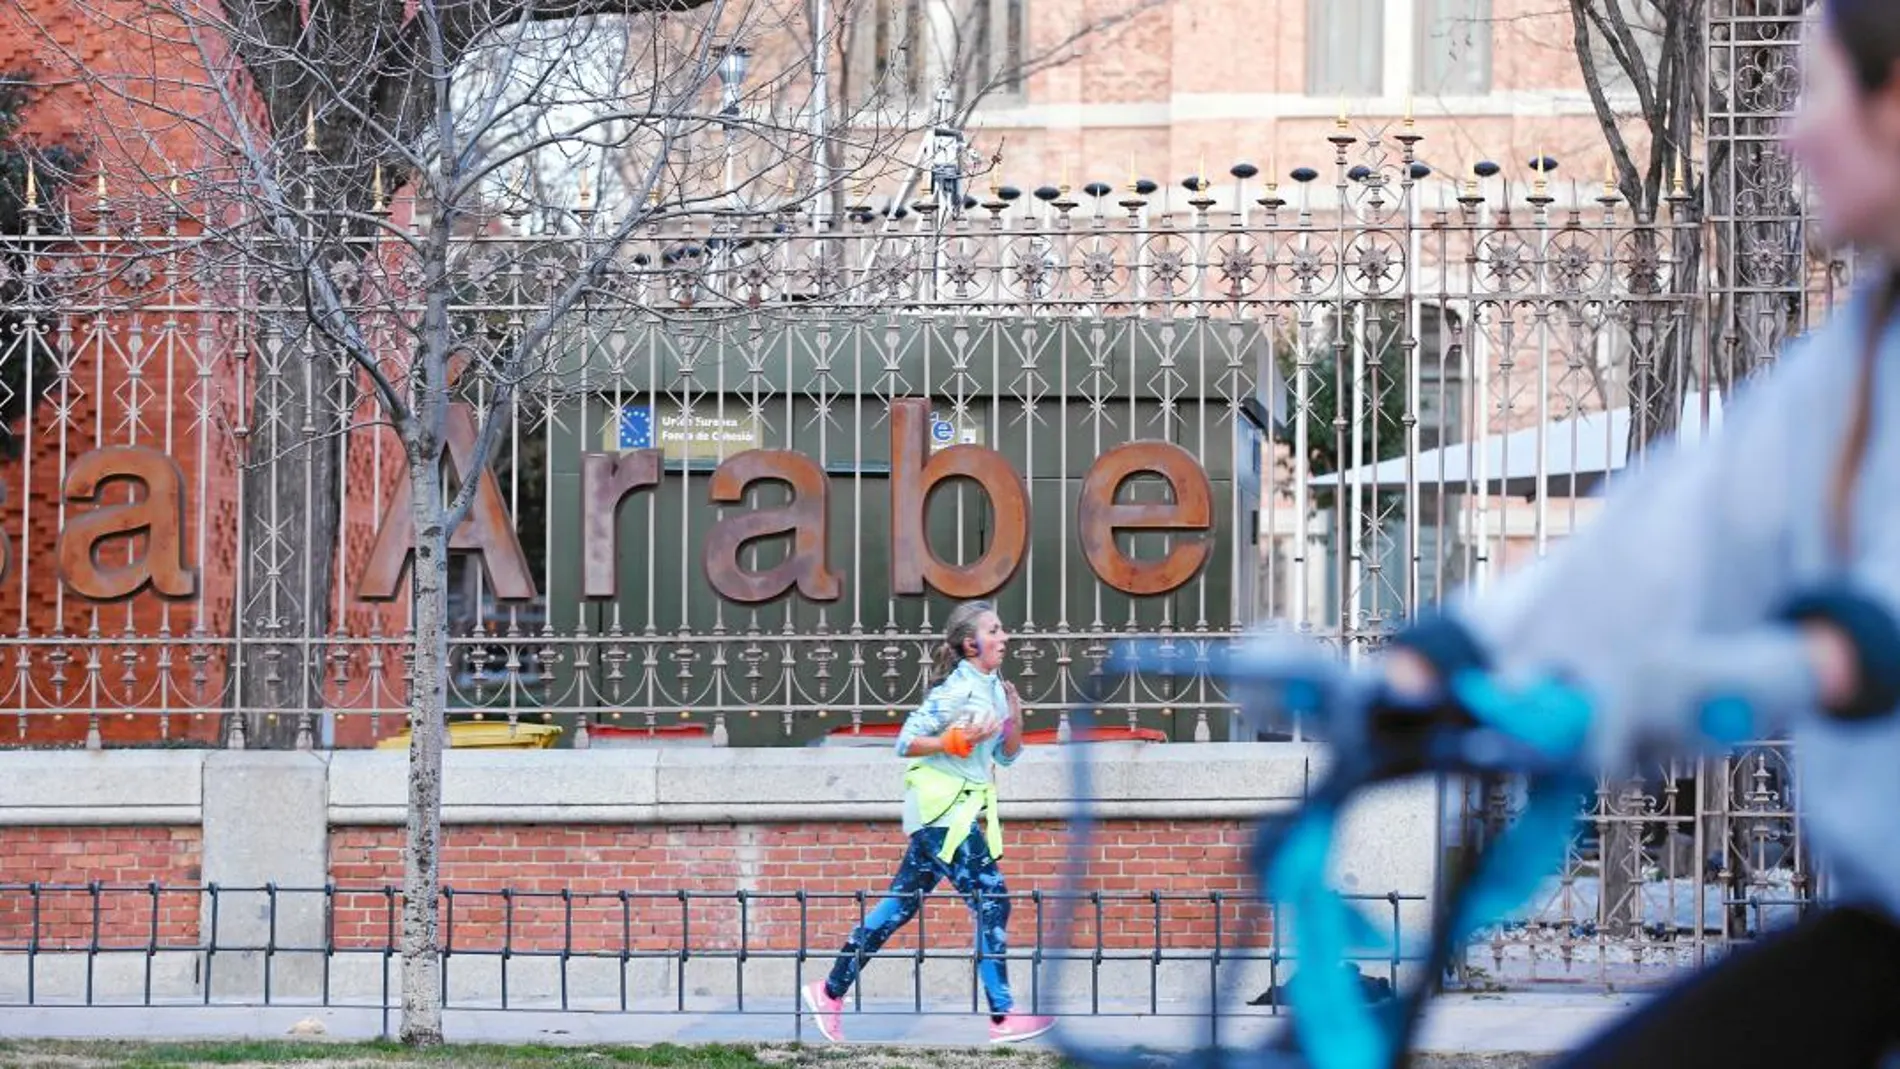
[825,826,1015,1014]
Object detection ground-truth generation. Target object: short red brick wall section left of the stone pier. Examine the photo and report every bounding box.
[0,828,201,951]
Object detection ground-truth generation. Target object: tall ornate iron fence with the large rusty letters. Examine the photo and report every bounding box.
[0,125,1693,744]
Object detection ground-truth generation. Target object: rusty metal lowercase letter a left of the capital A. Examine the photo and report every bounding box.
[59,446,198,602]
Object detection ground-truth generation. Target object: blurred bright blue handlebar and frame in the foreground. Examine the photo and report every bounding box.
[1055,638,1590,1069]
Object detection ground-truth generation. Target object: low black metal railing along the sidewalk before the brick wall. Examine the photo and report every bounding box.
[0,883,1425,1031]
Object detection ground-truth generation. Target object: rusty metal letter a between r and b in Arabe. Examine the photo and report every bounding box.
[703,450,844,604]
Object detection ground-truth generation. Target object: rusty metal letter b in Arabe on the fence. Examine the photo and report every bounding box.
[891,397,1030,598]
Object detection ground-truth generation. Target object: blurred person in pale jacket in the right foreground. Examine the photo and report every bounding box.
[1376,0,1900,1069]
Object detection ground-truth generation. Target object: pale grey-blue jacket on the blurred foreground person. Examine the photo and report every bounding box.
[1450,292,1900,917]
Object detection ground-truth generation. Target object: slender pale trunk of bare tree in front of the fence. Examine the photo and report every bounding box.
[401,442,448,1046]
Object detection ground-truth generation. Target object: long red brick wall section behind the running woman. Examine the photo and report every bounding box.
[331,815,1256,953]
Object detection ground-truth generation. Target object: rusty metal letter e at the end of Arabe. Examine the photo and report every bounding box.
[1075,442,1214,596]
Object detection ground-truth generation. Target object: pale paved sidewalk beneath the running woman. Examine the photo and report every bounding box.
[0,993,1640,1054]
